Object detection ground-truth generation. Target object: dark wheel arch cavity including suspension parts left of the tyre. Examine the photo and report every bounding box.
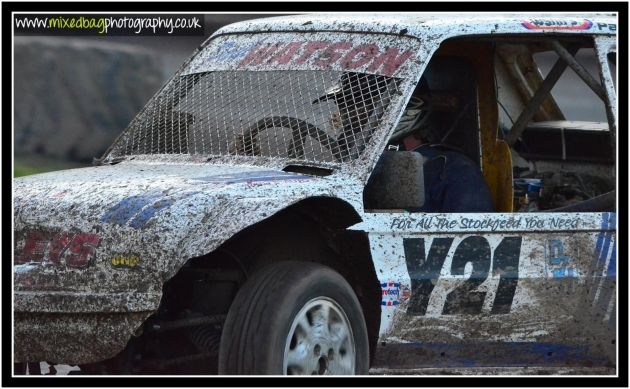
[139,196,381,363]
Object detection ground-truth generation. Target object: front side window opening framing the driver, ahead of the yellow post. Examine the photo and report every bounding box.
[364,44,495,213]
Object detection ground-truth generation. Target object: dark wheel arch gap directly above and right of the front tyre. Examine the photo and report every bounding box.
[217,196,381,360]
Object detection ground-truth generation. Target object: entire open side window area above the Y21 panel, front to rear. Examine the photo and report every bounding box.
[364,36,615,212]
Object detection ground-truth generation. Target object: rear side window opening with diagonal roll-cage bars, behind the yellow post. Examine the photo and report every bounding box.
[496,38,615,212]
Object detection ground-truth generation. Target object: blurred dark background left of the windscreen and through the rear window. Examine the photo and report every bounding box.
[14,14,606,176]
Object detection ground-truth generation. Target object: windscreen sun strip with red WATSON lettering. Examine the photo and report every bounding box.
[183,33,416,77]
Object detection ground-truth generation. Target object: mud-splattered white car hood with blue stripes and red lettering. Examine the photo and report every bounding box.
[14,162,356,304]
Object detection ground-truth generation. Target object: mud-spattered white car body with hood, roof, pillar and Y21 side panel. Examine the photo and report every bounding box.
[13,13,617,369]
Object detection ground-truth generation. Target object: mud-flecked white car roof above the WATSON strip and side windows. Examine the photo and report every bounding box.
[214,12,617,39]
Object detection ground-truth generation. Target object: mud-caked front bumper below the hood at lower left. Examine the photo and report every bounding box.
[14,292,161,365]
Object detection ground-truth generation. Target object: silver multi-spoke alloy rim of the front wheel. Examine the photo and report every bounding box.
[283,297,356,375]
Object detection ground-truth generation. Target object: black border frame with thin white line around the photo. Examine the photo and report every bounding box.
[0,1,628,387]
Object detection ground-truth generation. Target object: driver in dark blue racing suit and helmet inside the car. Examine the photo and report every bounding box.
[394,77,495,212]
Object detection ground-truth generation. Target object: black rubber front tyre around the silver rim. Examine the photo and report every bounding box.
[219,261,370,375]
